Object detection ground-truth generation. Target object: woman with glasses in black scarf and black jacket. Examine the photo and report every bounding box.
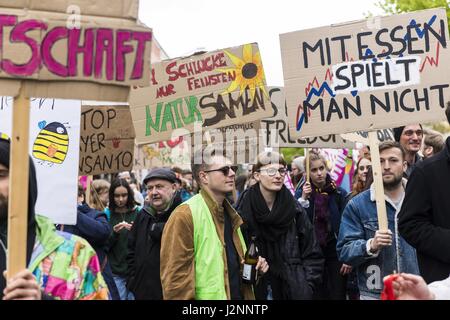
[237,152,323,300]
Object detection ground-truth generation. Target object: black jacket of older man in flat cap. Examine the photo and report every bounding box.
[127,192,181,300]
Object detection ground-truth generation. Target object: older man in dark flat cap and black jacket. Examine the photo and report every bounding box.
[127,168,181,300]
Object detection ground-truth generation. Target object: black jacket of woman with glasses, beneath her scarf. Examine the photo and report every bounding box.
[236,189,324,300]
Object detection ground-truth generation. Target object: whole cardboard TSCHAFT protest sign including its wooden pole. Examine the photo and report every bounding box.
[0,0,152,278]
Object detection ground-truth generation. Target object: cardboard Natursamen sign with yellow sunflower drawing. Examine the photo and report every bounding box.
[130,43,272,145]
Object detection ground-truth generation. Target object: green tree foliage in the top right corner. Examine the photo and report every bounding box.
[377,0,450,26]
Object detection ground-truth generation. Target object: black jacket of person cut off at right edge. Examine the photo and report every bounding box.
[398,138,450,283]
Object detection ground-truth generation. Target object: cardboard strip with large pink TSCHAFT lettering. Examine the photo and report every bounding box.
[0,14,152,85]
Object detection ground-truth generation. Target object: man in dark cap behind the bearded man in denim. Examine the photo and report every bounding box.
[394,124,423,178]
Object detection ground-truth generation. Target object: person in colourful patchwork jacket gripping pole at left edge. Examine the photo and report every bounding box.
[0,135,108,300]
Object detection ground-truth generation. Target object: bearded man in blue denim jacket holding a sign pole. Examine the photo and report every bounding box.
[336,141,419,300]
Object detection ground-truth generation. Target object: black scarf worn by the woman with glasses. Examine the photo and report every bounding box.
[239,183,297,298]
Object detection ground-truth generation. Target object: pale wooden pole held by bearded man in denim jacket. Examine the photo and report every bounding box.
[369,131,388,230]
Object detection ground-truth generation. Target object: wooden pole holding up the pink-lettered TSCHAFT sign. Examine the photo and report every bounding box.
[6,89,30,279]
